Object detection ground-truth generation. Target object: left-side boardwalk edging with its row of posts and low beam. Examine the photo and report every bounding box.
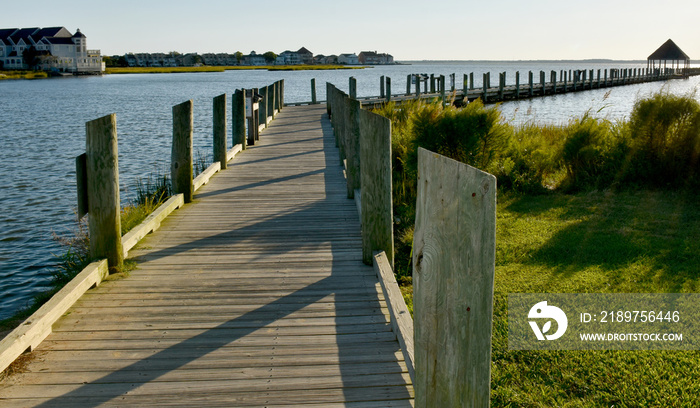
[0,80,284,372]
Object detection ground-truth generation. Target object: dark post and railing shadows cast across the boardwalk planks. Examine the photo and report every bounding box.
[40,107,410,407]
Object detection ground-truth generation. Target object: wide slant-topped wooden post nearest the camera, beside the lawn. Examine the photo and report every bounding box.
[416,148,496,407]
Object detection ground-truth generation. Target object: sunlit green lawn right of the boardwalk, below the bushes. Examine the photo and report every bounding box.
[400,190,700,408]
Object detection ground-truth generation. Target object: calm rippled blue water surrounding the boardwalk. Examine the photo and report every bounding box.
[0,62,700,319]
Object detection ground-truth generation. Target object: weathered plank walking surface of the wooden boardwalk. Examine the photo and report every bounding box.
[0,105,413,407]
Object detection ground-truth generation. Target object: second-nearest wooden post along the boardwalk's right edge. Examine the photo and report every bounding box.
[360,110,394,269]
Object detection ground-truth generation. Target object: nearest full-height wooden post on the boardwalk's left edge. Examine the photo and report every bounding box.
[85,114,124,271]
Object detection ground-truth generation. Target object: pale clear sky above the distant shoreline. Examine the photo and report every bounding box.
[5,0,700,60]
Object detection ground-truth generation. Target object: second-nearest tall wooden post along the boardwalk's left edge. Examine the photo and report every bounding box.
[170,100,194,203]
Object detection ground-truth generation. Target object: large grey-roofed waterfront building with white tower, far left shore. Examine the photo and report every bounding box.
[0,27,104,73]
